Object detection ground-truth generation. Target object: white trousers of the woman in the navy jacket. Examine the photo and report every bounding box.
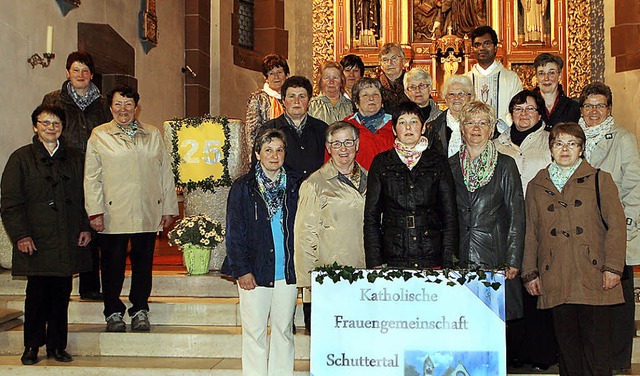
[238,280,298,376]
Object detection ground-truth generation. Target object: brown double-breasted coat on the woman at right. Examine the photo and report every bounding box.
[522,160,626,309]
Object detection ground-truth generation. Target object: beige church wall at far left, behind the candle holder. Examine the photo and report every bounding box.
[0,0,184,171]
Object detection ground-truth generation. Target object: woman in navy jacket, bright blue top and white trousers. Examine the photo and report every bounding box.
[222,129,299,376]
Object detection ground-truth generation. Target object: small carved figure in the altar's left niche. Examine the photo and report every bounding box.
[351,0,380,47]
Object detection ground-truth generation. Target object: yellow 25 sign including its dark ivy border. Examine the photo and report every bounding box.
[171,115,231,191]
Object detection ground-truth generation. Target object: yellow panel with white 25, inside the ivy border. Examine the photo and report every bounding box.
[176,120,226,182]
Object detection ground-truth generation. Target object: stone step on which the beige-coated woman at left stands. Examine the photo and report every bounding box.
[0,324,310,359]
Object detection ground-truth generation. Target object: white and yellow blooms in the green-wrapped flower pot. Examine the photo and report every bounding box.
[168,214,225,250]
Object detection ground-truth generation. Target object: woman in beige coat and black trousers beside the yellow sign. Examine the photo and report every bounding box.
[84,86,178,332]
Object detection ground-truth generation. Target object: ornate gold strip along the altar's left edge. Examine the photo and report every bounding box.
[312,0,339,86]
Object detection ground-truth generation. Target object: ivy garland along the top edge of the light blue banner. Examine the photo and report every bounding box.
[314,262,504,291]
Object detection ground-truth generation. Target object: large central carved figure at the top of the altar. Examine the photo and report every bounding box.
[413,0,487,40]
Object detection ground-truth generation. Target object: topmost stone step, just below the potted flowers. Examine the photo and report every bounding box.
[0,269,238,298]
